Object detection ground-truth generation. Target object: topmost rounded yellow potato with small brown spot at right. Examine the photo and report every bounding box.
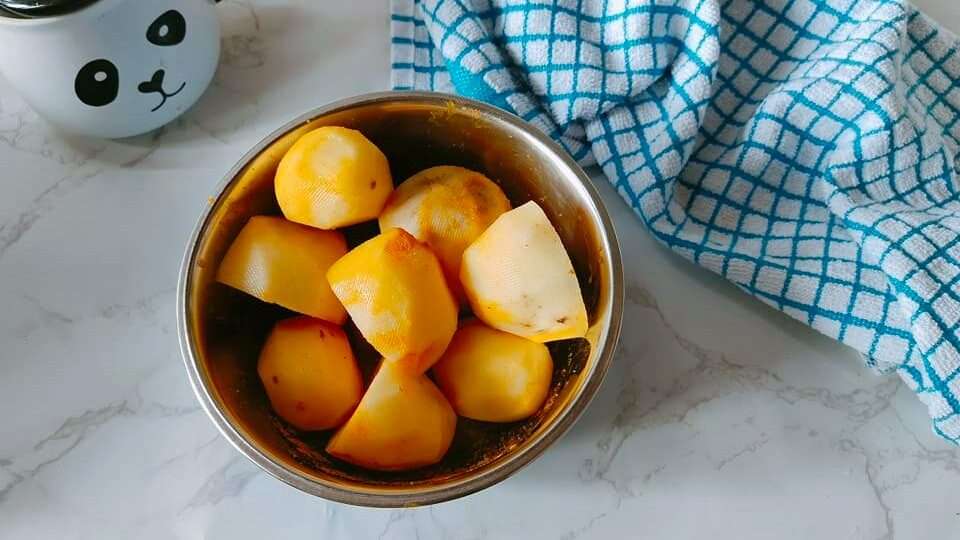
[274,126,393,229]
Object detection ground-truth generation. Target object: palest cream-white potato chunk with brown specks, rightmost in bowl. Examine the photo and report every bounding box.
[460,201,587,343]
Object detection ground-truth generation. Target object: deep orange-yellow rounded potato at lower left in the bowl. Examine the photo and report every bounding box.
[257,317,363,431]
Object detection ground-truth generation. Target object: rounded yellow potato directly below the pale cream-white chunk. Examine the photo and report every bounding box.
[433,320,553,422]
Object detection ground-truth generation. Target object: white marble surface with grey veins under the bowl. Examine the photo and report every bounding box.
[0,0,960,540]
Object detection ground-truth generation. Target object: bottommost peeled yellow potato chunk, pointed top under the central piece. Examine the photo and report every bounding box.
[327,362,457,471]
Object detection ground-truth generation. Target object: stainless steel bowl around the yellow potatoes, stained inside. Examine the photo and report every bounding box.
[178,92,623,507]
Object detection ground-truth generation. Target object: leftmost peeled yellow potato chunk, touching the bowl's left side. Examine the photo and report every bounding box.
[217,216,347,324]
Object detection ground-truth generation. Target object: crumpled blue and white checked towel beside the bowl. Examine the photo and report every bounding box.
[392,0,960,442]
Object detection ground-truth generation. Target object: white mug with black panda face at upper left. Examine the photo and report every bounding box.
[0,0,220,138]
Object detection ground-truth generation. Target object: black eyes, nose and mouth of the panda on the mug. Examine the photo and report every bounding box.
[74,9,187,112]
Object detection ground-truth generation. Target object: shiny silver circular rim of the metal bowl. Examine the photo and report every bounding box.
[176,91,624,508]
